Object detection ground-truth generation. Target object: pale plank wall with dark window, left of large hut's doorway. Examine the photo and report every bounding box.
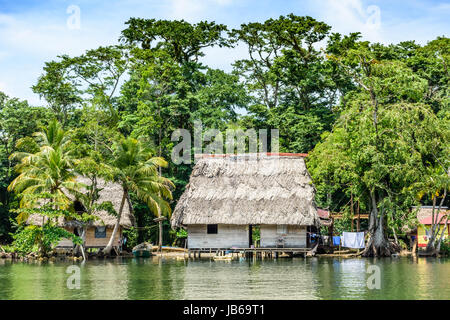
[187,224,248,249]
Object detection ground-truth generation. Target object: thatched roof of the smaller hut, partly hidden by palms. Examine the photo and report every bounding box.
[27,176,135,228]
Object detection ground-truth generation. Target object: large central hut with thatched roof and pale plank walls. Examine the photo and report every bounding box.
[171,154,319,249]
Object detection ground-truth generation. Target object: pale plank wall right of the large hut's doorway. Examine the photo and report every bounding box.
[260,225,306,248]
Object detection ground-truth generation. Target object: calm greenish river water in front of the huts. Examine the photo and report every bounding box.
[0,257,450,300]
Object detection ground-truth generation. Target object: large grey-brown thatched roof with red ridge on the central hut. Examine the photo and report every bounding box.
[171,153,319,228]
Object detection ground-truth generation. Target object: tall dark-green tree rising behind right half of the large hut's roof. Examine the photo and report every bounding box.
[230,14,338,152]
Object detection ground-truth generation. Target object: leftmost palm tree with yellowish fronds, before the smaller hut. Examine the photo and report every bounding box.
[8,121,80,222]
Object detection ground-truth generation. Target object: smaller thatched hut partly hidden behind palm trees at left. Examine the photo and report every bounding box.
[27,176,134,248]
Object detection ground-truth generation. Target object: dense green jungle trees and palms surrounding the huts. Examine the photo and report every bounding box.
[0,14,450,255]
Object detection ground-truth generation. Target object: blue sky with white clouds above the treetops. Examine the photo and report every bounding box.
[0,0,450,105]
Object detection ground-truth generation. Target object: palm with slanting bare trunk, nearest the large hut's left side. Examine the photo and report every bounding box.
[104,138,175,255]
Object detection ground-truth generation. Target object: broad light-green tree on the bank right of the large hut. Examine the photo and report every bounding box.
[309,38,449,255]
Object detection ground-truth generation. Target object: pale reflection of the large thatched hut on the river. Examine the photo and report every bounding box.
[184,259,318,299]
